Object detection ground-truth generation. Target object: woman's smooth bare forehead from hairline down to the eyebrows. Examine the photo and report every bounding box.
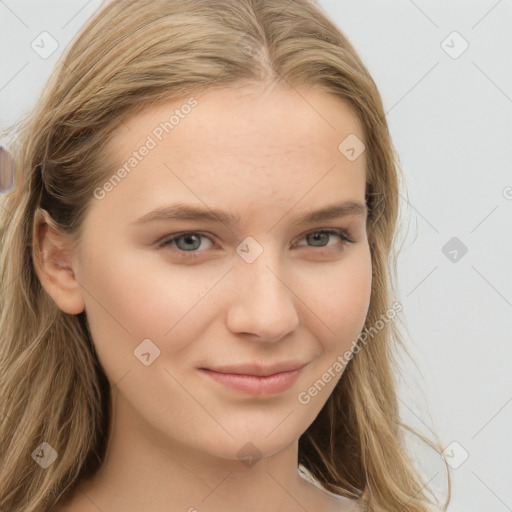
[91,86,365,224]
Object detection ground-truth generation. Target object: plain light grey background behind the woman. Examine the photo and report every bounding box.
[0,0,512,512]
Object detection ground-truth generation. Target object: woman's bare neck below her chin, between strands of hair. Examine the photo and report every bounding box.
[59,390,320,512]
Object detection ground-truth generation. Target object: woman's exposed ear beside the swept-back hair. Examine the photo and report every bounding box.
[32,208,85,315]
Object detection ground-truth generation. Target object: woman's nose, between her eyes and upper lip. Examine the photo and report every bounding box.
[227,251,299,342]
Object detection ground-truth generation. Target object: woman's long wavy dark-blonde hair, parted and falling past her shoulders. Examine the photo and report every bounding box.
[0,0,450,512]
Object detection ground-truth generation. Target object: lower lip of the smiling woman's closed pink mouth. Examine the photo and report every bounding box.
[200,368,300,395]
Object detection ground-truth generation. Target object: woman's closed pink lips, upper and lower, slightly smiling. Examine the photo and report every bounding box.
[199,363,305,395]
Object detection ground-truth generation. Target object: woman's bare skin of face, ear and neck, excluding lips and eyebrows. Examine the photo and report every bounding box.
[37,85,372,512]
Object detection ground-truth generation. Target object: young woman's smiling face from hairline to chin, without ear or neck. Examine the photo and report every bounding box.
[74,83,372,459]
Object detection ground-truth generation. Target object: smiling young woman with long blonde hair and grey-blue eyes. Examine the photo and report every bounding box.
[0,0,446,512]
